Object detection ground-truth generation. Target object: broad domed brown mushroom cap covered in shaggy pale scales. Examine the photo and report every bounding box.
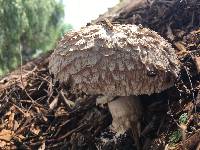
[49,24,180,96]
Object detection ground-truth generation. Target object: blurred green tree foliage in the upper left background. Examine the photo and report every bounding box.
[0,0,64,74]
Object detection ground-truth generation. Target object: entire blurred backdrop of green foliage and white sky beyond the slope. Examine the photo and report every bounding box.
[0,0,119,76]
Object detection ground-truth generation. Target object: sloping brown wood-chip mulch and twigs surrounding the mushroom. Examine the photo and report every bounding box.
[0,0,200,150]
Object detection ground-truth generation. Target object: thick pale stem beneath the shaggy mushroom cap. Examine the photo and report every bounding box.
[108,96,142,149]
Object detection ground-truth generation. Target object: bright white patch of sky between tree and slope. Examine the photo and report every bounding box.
[63,0,119,29]
